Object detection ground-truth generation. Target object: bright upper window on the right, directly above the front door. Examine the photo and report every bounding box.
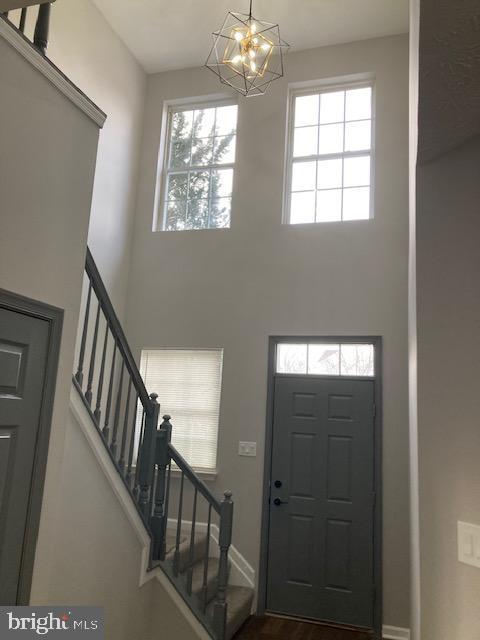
[287,86,372,224]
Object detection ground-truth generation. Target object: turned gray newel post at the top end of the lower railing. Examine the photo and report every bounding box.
[150,415,172,560]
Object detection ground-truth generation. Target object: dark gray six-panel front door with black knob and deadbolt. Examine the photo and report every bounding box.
[267,376,375,628]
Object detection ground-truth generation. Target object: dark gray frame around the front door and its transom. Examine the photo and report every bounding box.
[257,335,383,640]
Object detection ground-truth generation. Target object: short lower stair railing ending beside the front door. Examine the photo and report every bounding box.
[151,415,233,640]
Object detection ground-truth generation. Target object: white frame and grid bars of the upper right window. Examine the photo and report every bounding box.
[282,77,376,228]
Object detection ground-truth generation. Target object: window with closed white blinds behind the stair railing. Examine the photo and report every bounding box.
[140,349,223,471]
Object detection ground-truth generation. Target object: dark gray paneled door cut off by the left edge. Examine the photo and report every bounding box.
[0,307,50,605]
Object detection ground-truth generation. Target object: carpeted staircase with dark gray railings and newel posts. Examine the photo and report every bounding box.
[73,249,253,640]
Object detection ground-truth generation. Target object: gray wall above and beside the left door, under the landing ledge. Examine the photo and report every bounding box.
[0,32,98,599]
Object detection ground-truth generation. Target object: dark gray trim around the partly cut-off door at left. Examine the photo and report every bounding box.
[0,289,64,605]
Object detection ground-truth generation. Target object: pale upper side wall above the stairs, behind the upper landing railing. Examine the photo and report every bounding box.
[11,0,146,318]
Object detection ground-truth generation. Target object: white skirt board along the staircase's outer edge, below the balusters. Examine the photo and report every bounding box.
[70,385,212,640]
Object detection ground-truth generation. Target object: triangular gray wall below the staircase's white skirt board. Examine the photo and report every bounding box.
[43,412,153,640]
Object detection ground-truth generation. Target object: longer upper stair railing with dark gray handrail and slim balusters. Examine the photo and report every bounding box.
[73,249,159,526]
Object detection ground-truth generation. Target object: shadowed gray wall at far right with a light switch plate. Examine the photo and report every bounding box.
[417,137,480,640]
